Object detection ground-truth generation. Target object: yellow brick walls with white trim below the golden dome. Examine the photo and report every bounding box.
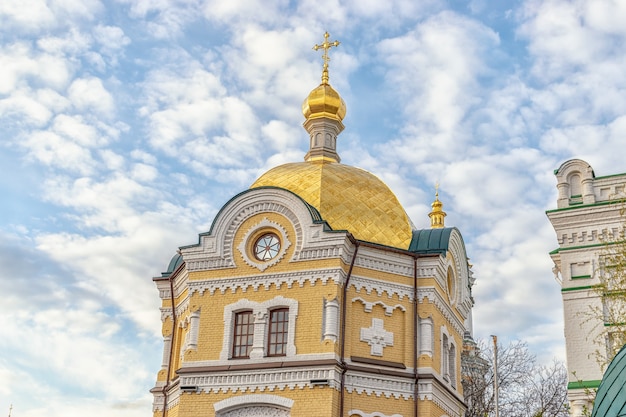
[152,189,471,417]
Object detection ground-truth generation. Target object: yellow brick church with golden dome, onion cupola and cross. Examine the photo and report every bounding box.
[151,34,473,417]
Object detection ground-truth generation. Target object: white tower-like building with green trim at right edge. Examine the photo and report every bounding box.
[547,159,626,417]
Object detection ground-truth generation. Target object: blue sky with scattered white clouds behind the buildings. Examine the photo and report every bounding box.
[0,0,626,417]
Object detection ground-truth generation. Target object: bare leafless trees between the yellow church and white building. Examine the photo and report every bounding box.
[463,341,569,417]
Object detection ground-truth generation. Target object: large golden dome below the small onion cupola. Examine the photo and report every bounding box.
[250,159,412,249]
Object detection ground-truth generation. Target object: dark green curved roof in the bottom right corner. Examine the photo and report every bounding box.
[591,346,626,417]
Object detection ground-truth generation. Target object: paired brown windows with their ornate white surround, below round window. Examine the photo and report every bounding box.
[220,296,298,360]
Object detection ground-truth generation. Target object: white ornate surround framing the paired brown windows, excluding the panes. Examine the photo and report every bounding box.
[220,296,298,360]
